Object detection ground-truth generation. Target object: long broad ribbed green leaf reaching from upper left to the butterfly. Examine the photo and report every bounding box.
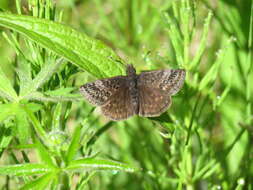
[0,13,125,77]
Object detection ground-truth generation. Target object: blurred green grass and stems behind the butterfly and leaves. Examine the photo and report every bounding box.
[0,0,253,190]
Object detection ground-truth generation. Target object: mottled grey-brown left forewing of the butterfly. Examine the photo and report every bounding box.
[80,76,127,106]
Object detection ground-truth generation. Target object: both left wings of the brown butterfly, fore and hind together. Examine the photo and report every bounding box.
[80,76,137,120]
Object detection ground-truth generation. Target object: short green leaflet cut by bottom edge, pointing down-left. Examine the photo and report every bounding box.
[21,172,57,190]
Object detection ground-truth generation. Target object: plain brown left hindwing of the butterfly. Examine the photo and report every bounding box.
[101,80,138,121]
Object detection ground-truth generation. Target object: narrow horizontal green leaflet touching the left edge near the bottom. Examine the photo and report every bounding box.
[0,164,55,176]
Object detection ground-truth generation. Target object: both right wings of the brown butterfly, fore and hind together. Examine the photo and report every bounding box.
[137,69,185,117]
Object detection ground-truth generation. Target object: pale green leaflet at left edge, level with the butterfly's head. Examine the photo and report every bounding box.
[0,65,17,100]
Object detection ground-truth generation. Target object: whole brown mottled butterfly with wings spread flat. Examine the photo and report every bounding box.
[80,65,185,121]
